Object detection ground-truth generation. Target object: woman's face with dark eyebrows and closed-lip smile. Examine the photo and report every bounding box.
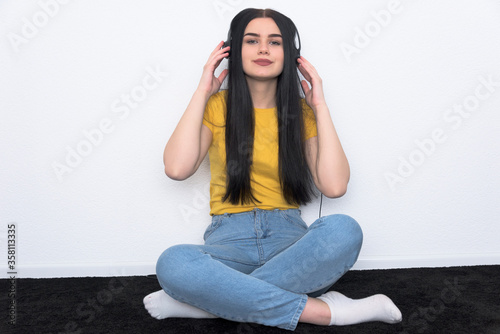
[241,18,284,80]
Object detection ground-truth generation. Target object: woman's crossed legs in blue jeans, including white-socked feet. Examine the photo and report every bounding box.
[144,215,400,330]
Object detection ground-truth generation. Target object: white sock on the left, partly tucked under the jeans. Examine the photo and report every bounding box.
[143,290,217,319]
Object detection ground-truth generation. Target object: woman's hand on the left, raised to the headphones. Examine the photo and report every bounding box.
[198,42,231,96]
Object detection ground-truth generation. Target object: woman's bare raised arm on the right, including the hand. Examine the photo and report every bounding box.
[298,57,350,198]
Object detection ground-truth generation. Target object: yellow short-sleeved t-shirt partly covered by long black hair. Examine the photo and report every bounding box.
[203,91,317,215]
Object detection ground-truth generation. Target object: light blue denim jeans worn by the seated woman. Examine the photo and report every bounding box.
[156,209,363,330]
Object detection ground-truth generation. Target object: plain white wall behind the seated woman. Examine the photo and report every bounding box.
[0,0,500,277]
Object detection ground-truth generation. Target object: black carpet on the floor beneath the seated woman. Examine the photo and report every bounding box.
[0,266,500,334]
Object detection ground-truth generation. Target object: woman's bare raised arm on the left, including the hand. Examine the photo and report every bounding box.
[163,42,229,180]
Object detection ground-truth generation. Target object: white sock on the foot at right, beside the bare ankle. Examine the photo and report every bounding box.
[318,291,402,326]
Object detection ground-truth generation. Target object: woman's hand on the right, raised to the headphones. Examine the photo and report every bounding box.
[297,56,326,111]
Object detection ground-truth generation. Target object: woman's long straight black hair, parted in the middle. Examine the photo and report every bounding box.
[222,8,313,205]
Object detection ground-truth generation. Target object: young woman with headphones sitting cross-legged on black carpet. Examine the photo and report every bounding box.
[144,9,401,330]
